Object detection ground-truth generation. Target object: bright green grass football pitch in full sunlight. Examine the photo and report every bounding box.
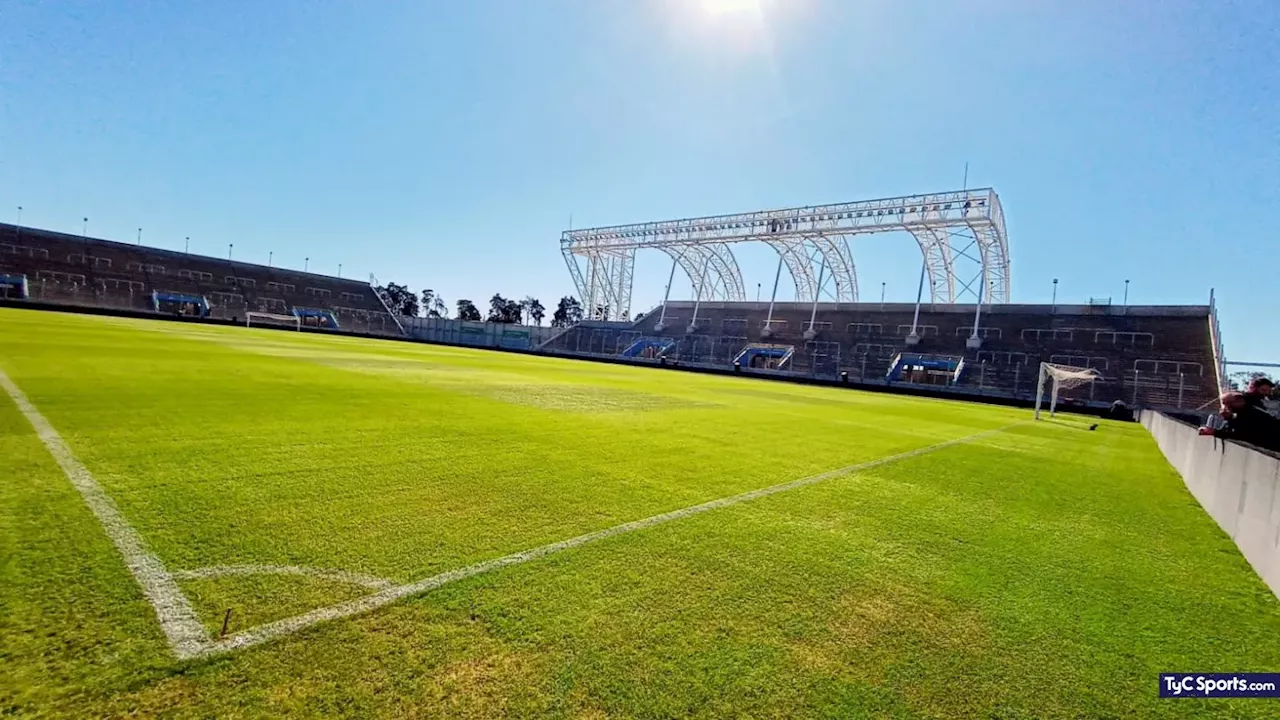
[0,309,1280,717]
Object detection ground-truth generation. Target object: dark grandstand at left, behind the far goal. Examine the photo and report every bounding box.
[0,224,402,334]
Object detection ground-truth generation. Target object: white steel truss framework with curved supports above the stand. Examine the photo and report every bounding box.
[561,187,1010,320]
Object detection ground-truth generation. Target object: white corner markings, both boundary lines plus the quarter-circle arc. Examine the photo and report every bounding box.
[0,361,1023,660]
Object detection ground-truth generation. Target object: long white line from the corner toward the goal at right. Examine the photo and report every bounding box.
[200,423,1023,655]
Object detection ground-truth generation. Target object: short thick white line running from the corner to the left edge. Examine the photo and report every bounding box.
[0,369,209,657]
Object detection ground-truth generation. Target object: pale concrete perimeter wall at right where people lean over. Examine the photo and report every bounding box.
[1142,410,1280,597]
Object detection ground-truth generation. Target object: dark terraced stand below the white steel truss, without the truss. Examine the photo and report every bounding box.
[543,301,1220,409]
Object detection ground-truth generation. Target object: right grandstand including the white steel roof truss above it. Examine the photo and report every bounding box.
[540,188,1224,409]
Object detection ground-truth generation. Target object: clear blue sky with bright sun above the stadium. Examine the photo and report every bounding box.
[0,0,1280,360]
